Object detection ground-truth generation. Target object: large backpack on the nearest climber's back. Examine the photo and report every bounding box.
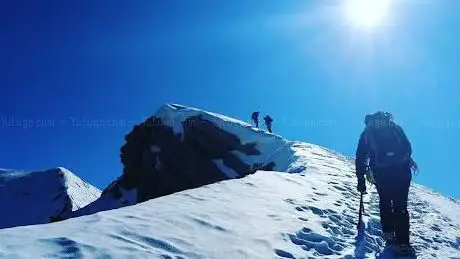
[364,112,411,167]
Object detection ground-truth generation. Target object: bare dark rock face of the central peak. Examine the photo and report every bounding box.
[113,115,275,202]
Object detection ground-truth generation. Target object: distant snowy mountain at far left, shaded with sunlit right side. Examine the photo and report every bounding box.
[0,167,101,228]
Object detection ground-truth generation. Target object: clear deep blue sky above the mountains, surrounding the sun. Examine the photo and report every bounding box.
[0,0,460,198]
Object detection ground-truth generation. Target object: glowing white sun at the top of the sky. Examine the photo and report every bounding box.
[345,0,390,28]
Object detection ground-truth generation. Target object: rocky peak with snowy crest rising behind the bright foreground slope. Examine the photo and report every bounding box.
[70,104,293,217]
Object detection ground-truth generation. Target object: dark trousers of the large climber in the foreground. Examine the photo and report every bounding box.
[374,164,412,247]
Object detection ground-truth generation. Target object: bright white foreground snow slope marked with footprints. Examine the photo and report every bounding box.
[0,143,460,259]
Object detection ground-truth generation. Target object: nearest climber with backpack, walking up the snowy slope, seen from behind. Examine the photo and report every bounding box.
[356,112,416,255]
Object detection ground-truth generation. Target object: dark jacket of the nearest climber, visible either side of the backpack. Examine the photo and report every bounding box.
[355,124,412,178]
